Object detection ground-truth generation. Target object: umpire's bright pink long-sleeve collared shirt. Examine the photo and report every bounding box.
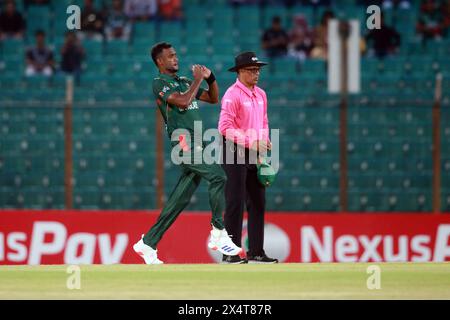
[219,79,269,148]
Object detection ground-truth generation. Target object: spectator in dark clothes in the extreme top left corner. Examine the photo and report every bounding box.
[0,0,25,40]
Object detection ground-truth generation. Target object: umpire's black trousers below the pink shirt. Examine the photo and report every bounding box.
[222,139,266,256]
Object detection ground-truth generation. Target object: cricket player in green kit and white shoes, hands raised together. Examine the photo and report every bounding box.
[133,42,242,264]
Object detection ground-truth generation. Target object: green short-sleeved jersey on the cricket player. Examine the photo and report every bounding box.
[152,73,204,139]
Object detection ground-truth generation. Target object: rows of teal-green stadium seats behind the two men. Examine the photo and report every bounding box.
[0,0,450,212]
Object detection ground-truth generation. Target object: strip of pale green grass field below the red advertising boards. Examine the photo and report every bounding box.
[0,263,450,300]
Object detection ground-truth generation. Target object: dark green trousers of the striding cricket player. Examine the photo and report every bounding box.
[143,163,227,249]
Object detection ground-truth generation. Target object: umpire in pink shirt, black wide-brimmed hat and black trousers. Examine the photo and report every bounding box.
[219,52,278,264]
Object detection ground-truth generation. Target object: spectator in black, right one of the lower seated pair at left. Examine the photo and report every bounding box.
[61,31,85,84]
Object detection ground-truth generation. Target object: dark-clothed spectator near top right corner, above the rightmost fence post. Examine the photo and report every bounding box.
[416,0,444,41]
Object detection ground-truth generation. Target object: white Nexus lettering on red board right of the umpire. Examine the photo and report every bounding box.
[300,224,450,262]
